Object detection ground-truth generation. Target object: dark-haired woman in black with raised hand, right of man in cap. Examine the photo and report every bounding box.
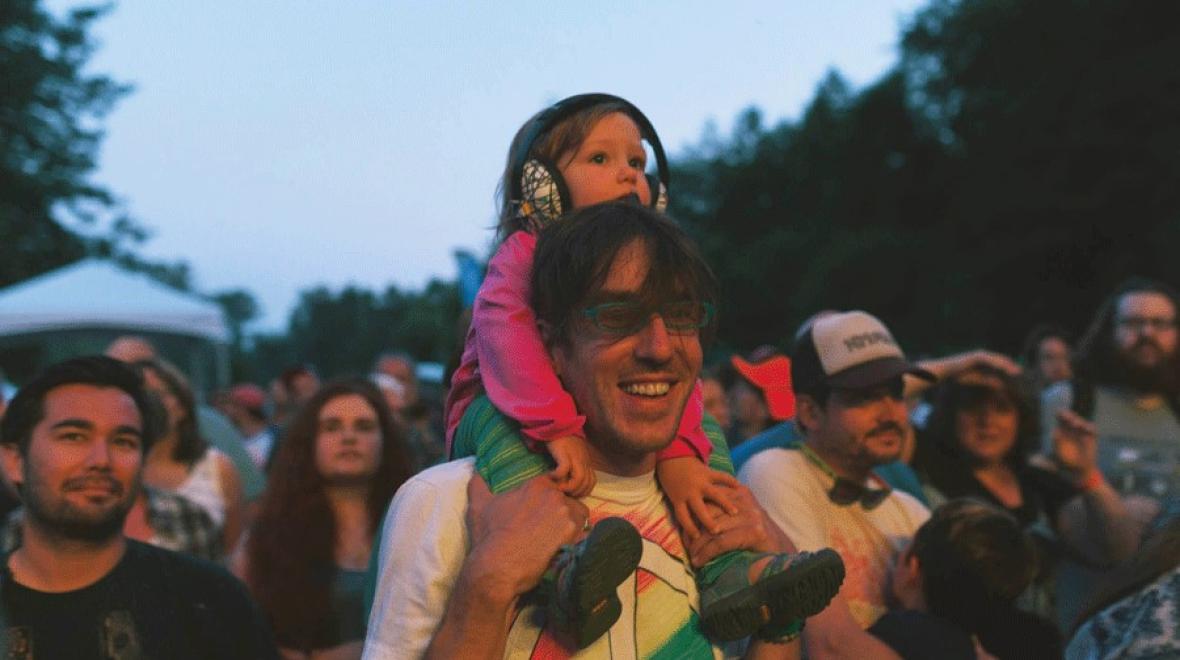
[915,366,1139,614]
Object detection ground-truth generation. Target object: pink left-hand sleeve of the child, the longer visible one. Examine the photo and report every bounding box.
[471,231,585,442]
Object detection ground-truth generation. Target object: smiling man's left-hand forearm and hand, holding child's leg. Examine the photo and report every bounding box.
[426,476,590,659]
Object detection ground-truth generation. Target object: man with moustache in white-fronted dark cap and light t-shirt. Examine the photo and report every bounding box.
[739,312,935,653]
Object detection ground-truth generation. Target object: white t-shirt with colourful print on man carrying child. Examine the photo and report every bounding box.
[363,458,722,659]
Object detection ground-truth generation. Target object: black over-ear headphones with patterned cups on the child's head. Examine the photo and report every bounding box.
[511,94,669,230]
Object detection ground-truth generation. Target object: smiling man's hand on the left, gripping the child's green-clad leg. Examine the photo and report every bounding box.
[465,475,590,602]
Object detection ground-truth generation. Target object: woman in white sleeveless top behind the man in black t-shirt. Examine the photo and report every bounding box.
[136,359,243,554]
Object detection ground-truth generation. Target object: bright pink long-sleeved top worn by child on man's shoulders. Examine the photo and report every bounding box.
[446,231,713,462]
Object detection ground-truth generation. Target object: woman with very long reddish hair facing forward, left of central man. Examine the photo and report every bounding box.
[235,380,411,660]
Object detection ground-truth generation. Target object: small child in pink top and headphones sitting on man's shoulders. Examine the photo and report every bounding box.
[446,94,844,648]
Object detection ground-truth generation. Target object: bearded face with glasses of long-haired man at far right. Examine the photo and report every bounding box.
[1114,292,1176,370]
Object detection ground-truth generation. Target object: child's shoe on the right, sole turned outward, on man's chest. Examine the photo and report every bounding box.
[701,548,844,641]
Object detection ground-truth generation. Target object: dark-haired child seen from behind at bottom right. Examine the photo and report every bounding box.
[868,499,1061,660]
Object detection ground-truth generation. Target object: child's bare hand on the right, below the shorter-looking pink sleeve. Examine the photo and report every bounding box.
[656,456,738,540]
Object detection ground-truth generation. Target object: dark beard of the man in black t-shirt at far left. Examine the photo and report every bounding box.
[20,471,139,543]
